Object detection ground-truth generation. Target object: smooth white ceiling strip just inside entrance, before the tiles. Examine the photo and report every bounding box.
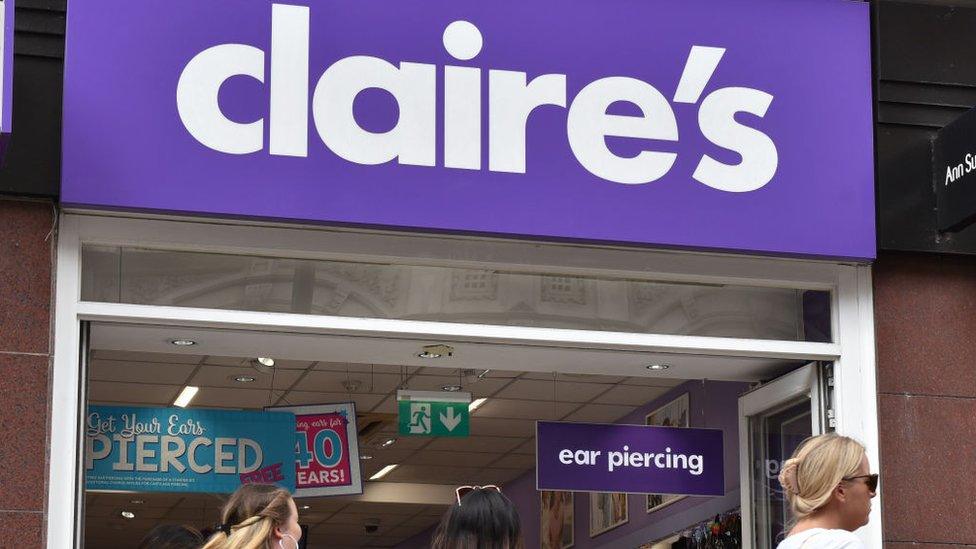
[91,324,796,381]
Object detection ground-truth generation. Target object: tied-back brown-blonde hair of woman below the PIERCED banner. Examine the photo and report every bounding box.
[197,484,291,549]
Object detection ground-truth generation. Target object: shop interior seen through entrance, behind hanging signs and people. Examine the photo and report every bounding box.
[84,323,820,549]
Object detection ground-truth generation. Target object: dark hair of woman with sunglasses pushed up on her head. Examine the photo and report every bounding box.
[430,488,524,549]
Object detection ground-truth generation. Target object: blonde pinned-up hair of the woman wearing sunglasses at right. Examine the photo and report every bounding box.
[779,433,864,521]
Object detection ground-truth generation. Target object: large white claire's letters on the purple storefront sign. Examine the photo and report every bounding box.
[176,4,776,192]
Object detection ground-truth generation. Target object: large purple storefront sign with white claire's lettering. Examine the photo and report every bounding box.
[61,0,875,259]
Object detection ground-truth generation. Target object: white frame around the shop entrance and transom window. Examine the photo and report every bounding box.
[47,212,882,548]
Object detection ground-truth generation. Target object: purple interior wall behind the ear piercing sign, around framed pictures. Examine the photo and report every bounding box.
[396,380,749,549]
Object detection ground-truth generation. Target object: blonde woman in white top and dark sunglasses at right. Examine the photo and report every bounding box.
[778,434,878,549]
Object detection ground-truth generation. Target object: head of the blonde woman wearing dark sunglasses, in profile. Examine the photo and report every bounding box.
[779,433,875,531]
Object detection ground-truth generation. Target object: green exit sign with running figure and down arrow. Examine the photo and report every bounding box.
[397,391,471,437]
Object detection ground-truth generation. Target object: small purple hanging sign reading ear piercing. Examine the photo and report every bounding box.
[535,421,725,496]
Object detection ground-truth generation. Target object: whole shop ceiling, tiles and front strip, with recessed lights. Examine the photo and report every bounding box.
[86,324,789,548]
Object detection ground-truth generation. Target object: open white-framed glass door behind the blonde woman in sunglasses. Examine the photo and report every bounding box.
[739,363,830,549]
